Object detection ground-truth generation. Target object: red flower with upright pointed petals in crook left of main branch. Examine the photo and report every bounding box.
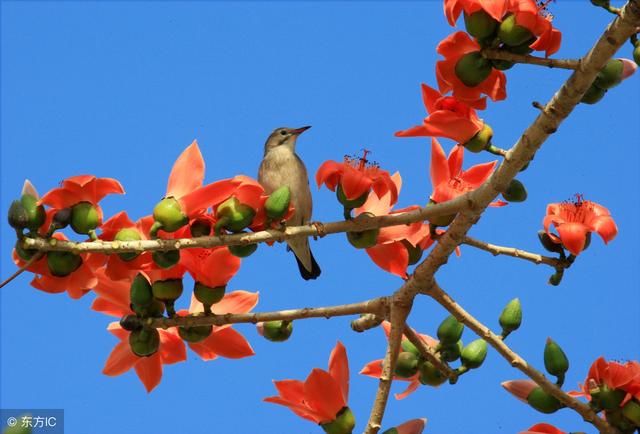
[431,139,506,206]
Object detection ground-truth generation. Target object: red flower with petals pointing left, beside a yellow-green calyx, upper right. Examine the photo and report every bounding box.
[396,84,484,143]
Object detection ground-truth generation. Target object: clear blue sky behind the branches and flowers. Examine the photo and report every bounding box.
[0,1,640,434]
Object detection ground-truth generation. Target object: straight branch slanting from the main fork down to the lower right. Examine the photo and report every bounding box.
[423,282,617,434]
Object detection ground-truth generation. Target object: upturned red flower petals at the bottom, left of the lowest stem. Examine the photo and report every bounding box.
[264,342,349,424]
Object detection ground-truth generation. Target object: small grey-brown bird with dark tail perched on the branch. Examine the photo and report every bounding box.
[258,126,320,280]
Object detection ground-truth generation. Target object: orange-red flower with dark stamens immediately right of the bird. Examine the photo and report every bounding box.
[316,150,398,204]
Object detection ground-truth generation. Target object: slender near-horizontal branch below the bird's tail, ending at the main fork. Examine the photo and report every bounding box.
[141,297,389,329]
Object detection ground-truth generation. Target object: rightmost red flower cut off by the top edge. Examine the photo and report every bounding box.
[509,0,562,56]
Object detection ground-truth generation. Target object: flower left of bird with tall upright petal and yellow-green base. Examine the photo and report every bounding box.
[151,140,235,236]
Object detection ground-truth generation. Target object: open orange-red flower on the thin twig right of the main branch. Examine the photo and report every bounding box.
[542,195,618,255]
